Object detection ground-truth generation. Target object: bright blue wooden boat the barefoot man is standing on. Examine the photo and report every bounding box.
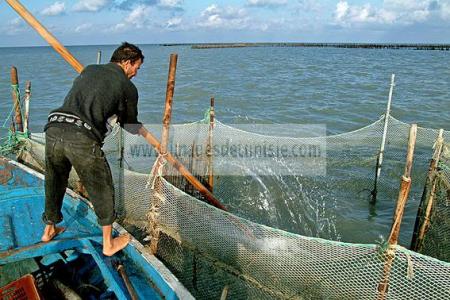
[0,157,193,299]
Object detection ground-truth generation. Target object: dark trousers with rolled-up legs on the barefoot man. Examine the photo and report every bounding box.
[42,124,116,226]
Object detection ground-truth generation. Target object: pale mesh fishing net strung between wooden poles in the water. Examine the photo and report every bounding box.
[7,117,450,299]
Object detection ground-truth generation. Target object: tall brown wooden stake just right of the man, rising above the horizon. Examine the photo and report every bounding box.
[150,54,178,255]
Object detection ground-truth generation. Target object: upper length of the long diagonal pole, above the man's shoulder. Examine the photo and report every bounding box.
[5,0,83,73]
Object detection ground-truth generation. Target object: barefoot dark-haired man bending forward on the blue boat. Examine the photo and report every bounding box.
[42,42,144,256]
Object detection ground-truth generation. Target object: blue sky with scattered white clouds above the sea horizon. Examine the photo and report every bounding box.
[0,0,450,47]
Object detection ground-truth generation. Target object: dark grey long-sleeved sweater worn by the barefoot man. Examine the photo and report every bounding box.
[45,63,142,142]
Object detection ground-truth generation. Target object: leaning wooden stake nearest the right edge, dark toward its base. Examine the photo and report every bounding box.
[410,129,444,252]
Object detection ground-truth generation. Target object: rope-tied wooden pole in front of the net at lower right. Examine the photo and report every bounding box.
[377,124,417,300]
